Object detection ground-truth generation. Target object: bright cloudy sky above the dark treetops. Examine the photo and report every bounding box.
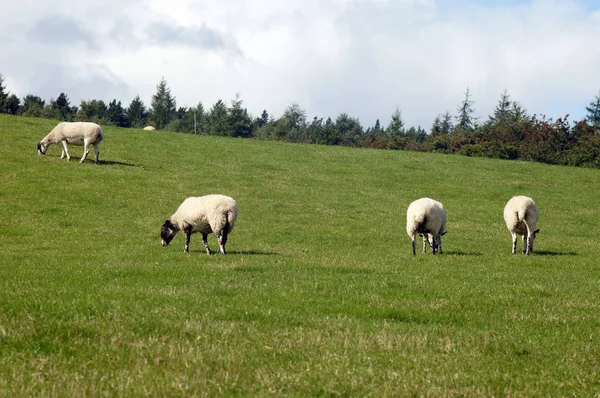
[0,0,600,130]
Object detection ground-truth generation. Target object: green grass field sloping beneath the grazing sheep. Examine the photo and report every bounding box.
[0,115,600,397]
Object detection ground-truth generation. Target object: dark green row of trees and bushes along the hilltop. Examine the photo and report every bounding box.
[0,75,600,168]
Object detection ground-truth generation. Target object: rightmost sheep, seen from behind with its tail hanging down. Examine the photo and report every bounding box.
[504,196,540,254]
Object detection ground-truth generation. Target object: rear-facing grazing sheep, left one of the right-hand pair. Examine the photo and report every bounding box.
[406,198,446,255]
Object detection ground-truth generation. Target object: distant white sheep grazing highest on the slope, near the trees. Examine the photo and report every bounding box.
[38,122,104,164]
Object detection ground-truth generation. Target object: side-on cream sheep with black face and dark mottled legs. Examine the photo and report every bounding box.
[160,195,238,255]
